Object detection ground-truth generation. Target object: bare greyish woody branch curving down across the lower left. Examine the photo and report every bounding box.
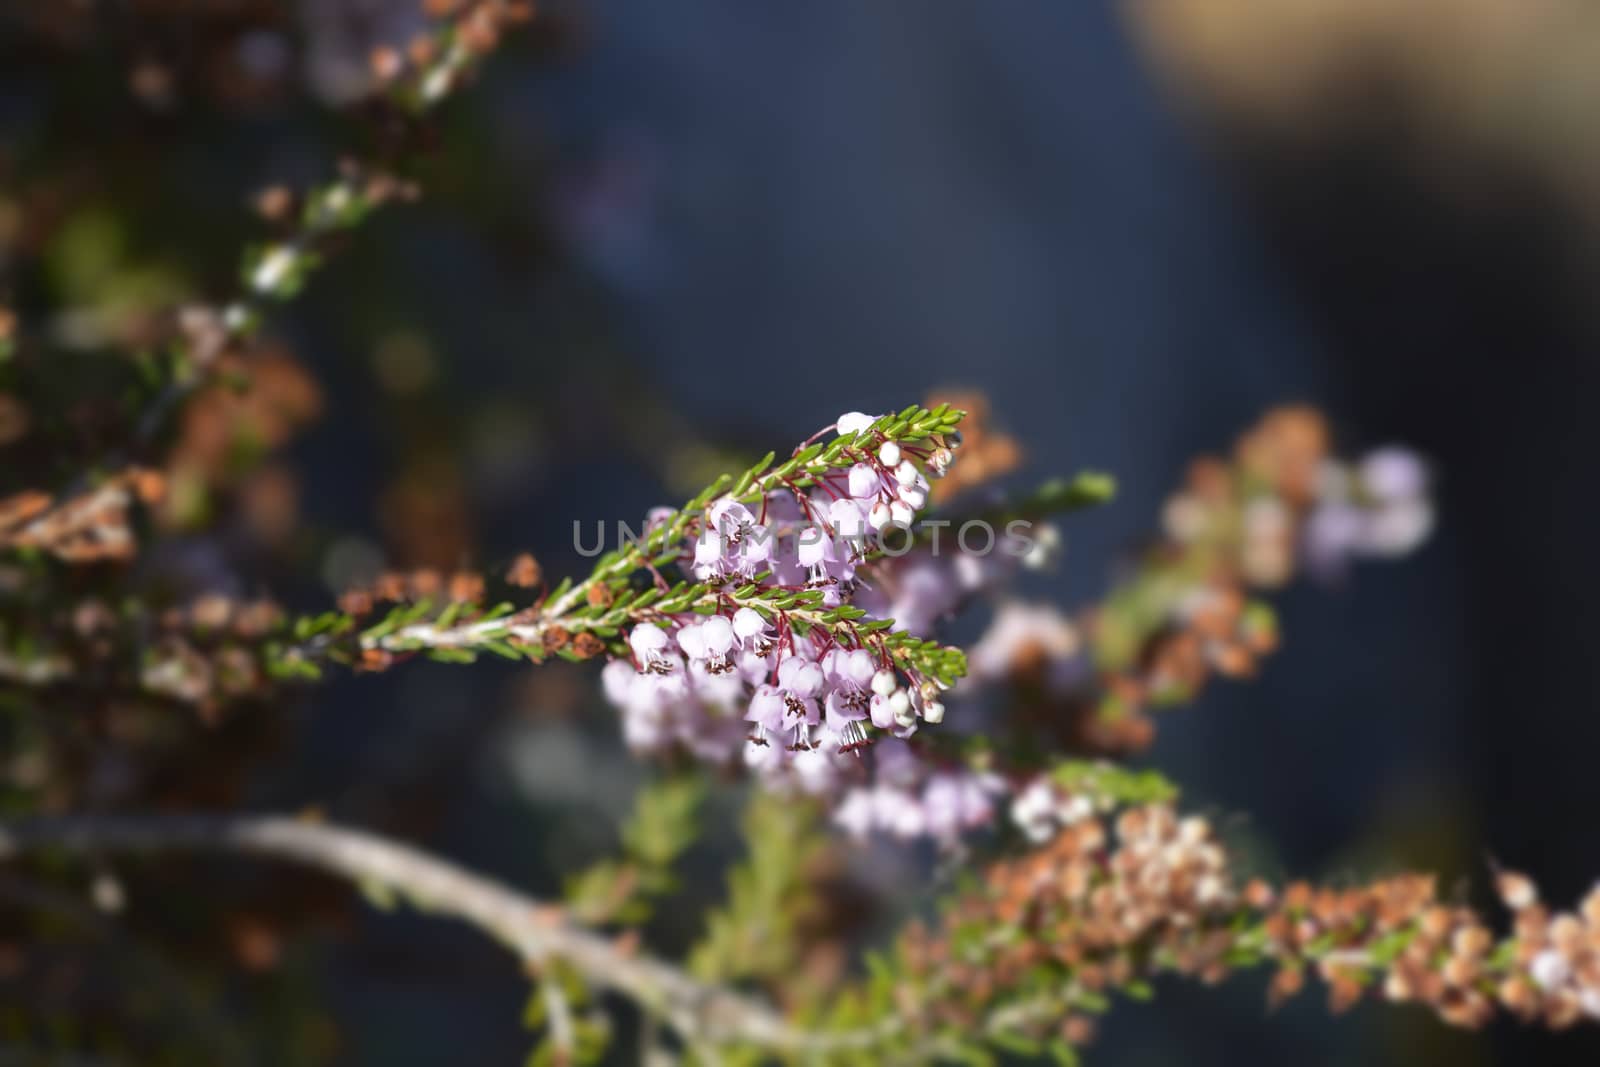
[0,816,813,1048]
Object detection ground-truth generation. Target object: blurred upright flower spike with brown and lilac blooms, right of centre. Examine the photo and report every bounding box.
[971,406,1432,755]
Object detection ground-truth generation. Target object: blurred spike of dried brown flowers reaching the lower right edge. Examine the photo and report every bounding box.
[899,806,1600,1038]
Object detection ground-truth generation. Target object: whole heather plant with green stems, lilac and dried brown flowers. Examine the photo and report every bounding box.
[0,0,1600,1064]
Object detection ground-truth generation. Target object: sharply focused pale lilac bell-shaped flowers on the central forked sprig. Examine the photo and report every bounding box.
[603,413,952,793]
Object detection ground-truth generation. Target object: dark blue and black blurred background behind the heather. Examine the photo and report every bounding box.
[0,0,1600,1067]
